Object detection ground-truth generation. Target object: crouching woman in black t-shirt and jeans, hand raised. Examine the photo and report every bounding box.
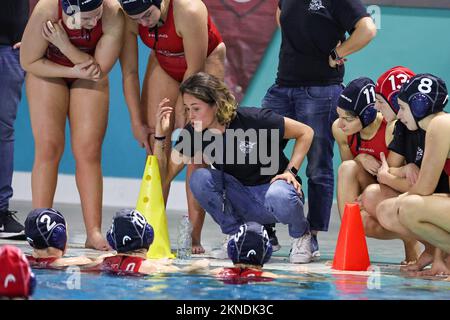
[155,73,314,263]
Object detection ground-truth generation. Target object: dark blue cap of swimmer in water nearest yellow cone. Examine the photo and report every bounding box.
[106,209,154,253]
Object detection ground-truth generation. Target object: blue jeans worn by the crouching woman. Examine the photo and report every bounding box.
[189,169,309,238]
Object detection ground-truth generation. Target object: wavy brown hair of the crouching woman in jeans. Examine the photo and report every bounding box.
[180,72,238,125]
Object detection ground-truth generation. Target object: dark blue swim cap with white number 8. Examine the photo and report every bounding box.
[398,73,448,122]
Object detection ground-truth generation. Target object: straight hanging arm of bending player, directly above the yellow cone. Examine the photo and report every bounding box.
[120,17,142,125]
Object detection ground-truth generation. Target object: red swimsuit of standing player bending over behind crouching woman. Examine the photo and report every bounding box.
[139,1,223,82]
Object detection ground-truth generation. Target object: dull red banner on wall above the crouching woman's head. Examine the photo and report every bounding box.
[203,0,278,101]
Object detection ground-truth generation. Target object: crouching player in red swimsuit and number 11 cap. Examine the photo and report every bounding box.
[332,78,392,217]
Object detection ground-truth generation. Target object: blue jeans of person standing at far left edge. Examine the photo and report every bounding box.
[0,46,25,210]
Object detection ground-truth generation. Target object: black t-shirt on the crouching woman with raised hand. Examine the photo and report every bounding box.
[174,107,289,186]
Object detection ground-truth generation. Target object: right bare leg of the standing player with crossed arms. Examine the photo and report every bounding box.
[69,78,109,250]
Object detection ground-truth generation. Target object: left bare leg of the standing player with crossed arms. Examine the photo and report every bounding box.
[26,73,69,208]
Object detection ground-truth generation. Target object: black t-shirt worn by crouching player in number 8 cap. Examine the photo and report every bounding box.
[388,121,450,193]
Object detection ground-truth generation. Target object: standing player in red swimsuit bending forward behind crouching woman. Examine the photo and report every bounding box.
[120,0,225,254]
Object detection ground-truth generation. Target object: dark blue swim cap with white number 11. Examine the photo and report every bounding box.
[338,77,377,128]
